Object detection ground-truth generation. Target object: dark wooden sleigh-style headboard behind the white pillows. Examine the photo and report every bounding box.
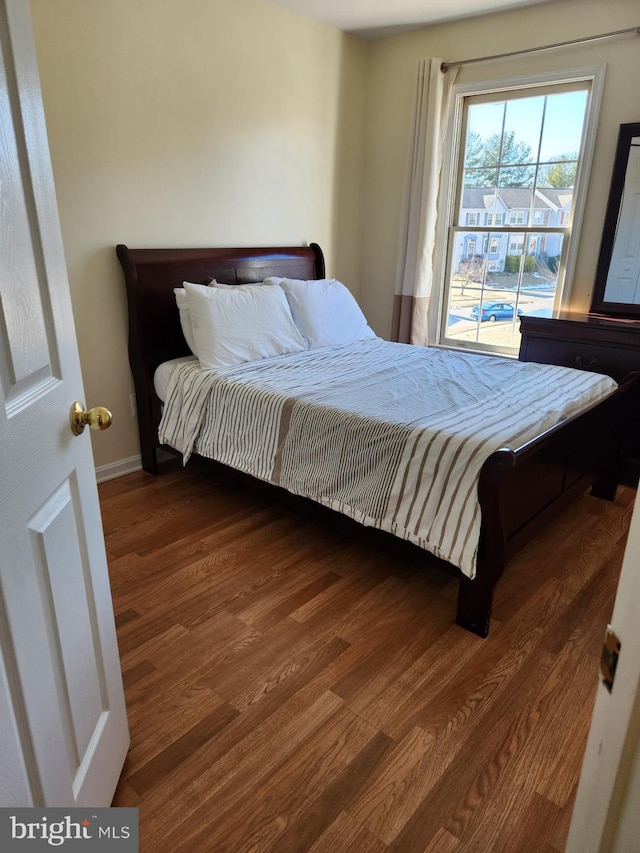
[116,243,325,474]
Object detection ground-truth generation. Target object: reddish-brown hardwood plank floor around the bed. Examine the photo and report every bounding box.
[100,465,635,853]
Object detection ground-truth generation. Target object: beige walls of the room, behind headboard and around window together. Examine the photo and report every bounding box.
[31,0,640,466]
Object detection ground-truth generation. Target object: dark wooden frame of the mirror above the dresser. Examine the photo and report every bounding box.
[591,122,640,317]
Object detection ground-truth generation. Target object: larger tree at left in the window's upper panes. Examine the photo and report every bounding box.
[464,130,534,187]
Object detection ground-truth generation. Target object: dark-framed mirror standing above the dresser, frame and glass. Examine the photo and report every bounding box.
[591,122,640,317]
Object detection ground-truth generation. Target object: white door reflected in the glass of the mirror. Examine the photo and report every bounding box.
[604,142,640,305]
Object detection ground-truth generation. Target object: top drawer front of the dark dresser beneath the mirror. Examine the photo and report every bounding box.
[520,336,640,382]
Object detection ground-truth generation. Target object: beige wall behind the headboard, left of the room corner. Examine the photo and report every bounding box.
[31,0,366,467]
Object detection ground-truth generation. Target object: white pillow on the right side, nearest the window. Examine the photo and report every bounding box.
[265,278,376,349]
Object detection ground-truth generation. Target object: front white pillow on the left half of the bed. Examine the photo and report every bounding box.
[185,282,307,370]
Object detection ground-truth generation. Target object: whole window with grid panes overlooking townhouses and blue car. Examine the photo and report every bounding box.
[432,69,603,355]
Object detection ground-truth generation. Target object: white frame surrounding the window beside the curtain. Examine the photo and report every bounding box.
[428,65,606,358]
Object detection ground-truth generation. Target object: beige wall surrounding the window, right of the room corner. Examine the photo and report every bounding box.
[360,0,640,337]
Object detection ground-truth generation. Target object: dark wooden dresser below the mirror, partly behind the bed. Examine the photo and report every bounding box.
[519,311,640,482]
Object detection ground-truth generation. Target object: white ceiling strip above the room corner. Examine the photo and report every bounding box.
[273,0,550,38]
